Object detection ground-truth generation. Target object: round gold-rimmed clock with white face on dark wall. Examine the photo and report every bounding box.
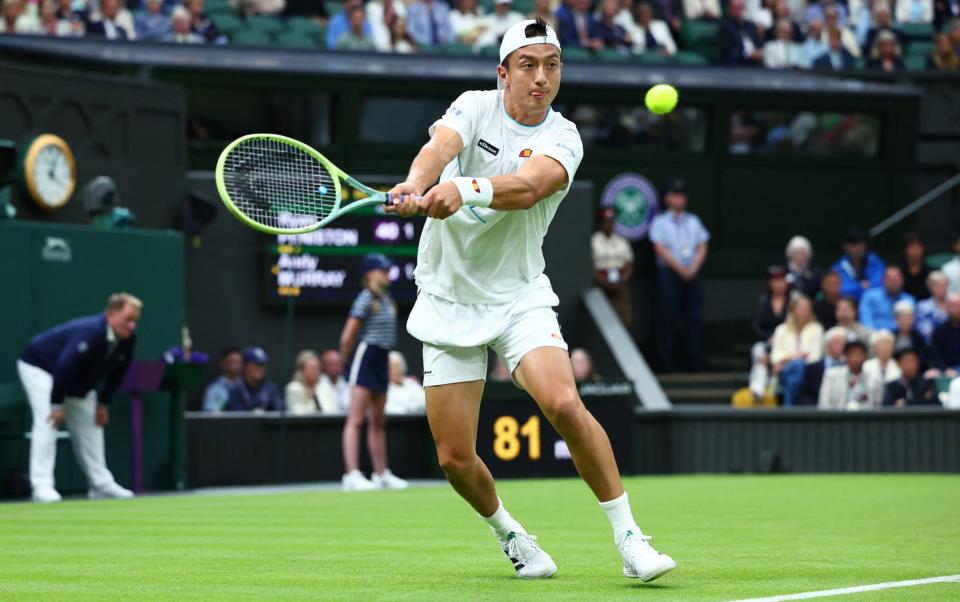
[21,134,77,211]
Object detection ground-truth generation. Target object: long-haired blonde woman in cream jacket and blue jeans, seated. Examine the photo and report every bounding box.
[770,294,823,407]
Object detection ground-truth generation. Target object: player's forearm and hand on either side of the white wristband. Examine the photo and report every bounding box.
[420,155,567,219]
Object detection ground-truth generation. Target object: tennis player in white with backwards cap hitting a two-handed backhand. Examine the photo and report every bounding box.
[388,19,676,581]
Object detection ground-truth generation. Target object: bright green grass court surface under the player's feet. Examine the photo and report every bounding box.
[0,476,960,600]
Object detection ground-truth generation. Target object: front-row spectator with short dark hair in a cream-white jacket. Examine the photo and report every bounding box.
[817,341,883,410]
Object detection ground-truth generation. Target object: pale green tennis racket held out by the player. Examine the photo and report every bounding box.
[216,134,404,234]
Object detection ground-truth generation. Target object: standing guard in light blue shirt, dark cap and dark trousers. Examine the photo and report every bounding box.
[650,178,710,372]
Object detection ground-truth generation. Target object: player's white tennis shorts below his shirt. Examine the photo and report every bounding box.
[407,284,567,387]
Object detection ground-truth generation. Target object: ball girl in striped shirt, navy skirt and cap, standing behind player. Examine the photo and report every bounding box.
[340,253,407,491]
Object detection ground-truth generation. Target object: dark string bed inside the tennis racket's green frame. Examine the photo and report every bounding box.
[223,138,339,229]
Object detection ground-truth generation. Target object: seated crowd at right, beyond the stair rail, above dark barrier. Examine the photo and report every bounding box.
[750,230,960,410]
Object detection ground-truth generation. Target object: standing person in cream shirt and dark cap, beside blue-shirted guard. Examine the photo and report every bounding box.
[590,207,633,330]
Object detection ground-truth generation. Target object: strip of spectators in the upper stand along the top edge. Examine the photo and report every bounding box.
[0,0,960,72]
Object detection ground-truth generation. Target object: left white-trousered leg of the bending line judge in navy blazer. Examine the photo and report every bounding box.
[17,361,61,502]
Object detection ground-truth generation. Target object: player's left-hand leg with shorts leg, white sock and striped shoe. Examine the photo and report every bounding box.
[423,344,557,579]
